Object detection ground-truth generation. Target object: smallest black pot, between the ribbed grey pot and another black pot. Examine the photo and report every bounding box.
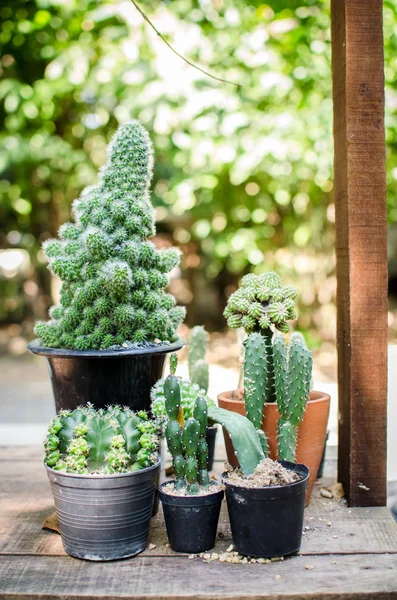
[159,482,223,553]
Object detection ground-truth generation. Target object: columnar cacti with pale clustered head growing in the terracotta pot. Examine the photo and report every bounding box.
[224,272,312,461]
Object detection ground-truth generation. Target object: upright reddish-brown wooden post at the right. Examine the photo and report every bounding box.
[331,0,387,506]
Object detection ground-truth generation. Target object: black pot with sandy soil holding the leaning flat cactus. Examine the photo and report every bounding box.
[223,461,309,558]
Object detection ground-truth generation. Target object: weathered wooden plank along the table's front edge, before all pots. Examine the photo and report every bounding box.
[0,555,397,600]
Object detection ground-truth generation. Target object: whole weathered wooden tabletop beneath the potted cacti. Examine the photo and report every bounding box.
[0,447,397,600]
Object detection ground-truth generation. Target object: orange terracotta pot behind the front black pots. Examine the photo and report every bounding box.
[218,389,330,502]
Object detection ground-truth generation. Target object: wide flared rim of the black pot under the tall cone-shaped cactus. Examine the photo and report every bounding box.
[27,339,186,358]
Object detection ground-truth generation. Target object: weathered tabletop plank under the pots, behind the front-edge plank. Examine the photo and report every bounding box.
[0,450,397,556]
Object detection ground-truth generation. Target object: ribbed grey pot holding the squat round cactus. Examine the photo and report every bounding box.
[46,461,160,561]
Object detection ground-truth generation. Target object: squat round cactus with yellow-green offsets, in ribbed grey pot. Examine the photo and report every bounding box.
[44,405,160,561]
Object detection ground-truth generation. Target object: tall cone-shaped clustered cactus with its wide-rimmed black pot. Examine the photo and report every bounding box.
[28,121,185,410]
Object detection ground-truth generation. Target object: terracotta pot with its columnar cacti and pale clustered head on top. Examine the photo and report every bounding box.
[218,272,330,501]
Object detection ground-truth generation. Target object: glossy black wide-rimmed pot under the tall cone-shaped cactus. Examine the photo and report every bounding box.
[28,340,184,412]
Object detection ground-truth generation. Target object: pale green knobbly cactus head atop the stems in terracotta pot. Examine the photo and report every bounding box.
[224,271,297,335]
